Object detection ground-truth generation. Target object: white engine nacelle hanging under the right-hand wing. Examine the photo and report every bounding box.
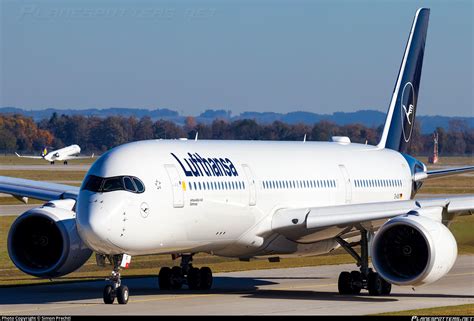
[372,209,458,286]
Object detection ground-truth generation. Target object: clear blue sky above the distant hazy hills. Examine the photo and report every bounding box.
[0,0,474,116]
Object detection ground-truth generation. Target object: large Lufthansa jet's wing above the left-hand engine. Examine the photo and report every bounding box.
[0,176,79,201]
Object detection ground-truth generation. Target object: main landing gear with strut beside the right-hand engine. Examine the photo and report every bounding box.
[336,228,392,296]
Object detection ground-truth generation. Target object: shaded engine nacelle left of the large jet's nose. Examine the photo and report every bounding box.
[8,200,92,278]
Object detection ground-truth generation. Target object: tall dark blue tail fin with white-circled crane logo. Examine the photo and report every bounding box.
[377,8,430,152]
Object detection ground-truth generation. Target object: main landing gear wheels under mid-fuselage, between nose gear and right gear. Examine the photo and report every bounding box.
[158,254,212,290]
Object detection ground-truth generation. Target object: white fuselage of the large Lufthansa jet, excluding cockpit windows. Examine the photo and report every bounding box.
[76,140,412,257]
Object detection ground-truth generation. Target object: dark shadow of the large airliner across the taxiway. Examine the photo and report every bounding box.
[0,277,474,305]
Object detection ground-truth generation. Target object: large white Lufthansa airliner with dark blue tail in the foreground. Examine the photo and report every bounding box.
[0,9,474,304]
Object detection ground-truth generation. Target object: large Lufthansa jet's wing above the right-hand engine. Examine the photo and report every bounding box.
[272,195,474,235]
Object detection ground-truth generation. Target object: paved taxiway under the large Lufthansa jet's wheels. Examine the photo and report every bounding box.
[0,256,474,315]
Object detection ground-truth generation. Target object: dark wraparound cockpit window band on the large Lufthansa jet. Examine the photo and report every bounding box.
[82,175,145,193]
